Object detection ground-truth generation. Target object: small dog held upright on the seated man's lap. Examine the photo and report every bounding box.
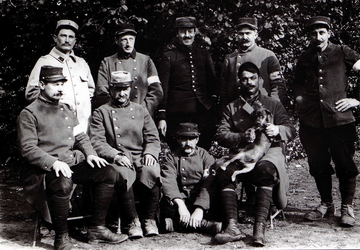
[221,103,273,181]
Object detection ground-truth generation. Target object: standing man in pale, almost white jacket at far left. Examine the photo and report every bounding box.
[25,20,95,133]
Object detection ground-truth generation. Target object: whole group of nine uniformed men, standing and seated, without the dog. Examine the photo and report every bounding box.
[18,16,360,250]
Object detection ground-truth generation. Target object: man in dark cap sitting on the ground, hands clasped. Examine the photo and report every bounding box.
[161,123,222,234]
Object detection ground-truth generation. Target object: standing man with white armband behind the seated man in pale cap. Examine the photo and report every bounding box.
[95,23,163,115]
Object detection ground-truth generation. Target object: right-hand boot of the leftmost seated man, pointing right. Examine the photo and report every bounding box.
[88,226,128,244]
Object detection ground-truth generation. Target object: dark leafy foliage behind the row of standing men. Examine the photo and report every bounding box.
[0,0,360,162]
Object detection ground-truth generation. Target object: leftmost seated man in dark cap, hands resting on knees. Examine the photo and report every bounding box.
[18,66,128,250]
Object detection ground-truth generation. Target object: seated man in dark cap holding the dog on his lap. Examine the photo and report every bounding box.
[215,62,296,246]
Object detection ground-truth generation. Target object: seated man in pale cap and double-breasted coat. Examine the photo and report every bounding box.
[90,71,161,238]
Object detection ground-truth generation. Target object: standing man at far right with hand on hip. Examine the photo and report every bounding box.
[292,16,360,226]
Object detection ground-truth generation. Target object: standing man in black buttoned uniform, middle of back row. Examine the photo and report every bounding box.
[158,17,218,149]
